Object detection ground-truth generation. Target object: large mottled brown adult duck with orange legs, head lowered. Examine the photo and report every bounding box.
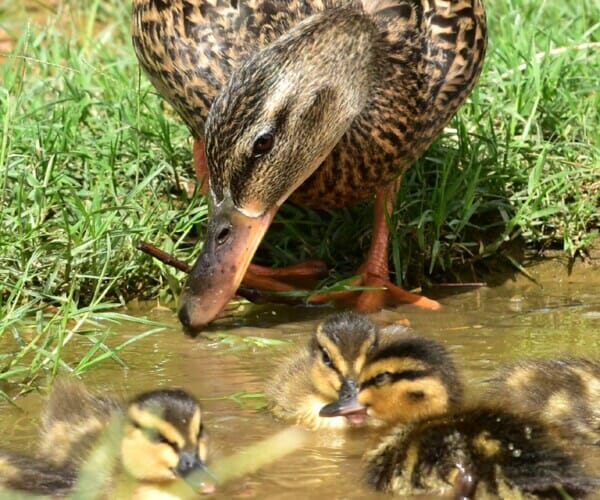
[131,0,486,331]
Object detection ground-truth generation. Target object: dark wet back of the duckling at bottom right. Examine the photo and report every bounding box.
[367,408,600,499]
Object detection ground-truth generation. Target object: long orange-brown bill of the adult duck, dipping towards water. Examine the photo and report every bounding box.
[179,198,278,335]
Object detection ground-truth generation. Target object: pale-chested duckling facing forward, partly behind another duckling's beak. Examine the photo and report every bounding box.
[265,312,379,430]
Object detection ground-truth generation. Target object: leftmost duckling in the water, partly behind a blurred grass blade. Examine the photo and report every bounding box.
[0,379,214,499]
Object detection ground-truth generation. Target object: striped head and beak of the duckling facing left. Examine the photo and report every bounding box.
[322,337,462,424]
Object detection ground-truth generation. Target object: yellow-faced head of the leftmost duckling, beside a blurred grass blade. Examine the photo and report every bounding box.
[121,389,214,491]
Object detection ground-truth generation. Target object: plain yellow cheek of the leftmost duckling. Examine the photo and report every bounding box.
[121,429,179,482]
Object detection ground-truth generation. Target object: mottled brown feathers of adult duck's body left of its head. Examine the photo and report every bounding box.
[131,0,238,138]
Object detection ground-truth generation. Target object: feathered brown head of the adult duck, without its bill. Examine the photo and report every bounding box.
[205,9,383,206]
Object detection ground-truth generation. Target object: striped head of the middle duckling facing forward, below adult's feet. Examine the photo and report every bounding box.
[309,312,379,424]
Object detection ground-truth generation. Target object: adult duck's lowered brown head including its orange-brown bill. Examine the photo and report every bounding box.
[179,11,375,333]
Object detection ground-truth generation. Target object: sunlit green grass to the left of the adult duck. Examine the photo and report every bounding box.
[0,2,206,390]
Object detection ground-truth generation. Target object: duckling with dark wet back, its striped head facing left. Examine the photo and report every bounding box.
[322,340,600,498]
